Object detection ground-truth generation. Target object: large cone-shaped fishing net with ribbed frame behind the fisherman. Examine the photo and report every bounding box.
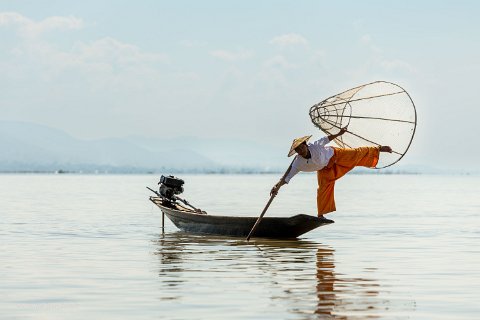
[310,81,417,169]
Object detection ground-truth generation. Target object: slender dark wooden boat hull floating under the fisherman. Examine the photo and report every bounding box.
[150,196,334,238]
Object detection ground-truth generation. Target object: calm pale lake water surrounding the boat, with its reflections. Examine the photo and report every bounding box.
[0,174,480,320]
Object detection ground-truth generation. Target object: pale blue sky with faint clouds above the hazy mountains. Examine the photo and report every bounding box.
[0,0,480,169]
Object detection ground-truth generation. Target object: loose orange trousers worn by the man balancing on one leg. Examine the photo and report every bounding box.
[317,147,380,216]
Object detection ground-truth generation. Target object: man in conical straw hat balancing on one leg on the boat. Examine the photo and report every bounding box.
[270,127,392,218]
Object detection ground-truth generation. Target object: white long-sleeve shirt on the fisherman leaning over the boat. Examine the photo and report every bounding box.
[285,137,333,183]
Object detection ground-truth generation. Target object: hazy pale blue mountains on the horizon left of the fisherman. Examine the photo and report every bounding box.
[0,121,288,172]
